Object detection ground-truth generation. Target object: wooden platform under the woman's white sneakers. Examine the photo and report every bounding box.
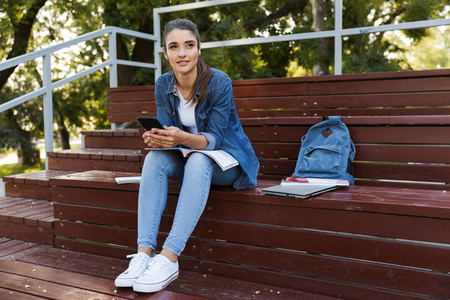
[0,243,334,300]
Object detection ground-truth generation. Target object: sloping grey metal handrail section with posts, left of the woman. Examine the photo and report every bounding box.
[0,26,160,170]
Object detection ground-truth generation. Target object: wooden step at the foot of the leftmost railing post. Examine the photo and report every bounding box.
[48,148,144,172]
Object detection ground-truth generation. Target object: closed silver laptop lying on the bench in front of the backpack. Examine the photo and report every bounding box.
[261,184,339,199]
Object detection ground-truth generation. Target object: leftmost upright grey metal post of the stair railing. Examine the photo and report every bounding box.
[42,53,53,170]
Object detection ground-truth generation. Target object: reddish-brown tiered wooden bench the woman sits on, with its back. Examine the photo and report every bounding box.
[4,70,450,299]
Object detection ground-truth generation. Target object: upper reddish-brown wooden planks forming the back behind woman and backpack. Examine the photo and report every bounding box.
[108,70,450,190]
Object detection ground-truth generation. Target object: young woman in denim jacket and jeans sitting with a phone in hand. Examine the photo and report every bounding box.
[115,19,259,293]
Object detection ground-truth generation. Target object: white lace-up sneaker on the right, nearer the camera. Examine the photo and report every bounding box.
[133,254,178,293]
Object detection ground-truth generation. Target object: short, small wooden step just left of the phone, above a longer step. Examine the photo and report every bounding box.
[82,128,142,150]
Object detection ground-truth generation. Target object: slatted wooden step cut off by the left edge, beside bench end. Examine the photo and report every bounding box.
[0,197,55,245]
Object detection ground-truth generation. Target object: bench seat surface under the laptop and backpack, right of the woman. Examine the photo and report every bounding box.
[208,185,450,216]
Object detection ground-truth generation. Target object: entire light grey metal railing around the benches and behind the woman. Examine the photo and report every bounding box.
[0,0,450,169]
